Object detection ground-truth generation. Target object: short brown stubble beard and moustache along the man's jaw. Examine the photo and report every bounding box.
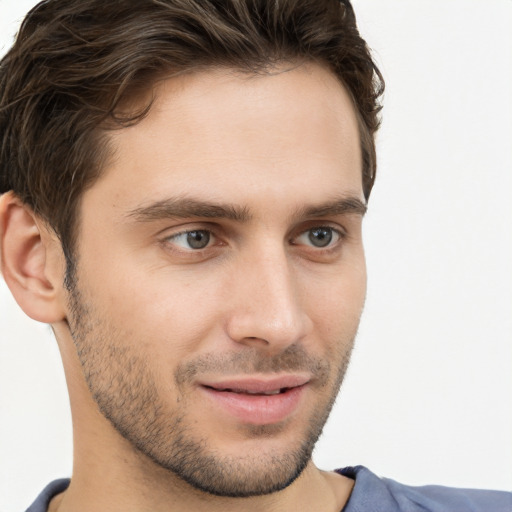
[68,282,355,497]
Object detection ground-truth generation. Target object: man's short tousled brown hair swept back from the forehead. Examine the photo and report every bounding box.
[0,0,384,263]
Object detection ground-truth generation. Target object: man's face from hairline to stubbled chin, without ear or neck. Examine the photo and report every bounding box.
[68,65,366,496]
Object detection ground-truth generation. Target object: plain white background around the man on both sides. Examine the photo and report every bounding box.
[0,0,512,512]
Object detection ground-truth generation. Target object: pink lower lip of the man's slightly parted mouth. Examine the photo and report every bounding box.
[202,386,305,425]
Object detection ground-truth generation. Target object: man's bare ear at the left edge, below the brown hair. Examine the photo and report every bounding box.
[0,192,65,324]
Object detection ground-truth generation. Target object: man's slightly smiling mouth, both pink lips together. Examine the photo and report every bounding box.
[200,376,309,425]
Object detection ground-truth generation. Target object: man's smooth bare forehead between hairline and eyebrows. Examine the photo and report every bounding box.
[90,64,362,217]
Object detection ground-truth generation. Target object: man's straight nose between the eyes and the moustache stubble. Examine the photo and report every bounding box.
[227,248,312,353]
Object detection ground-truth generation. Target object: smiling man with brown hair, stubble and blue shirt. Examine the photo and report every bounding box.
[0,0,511,511]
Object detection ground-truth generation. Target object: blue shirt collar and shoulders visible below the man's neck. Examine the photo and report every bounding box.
[26,466,512,512]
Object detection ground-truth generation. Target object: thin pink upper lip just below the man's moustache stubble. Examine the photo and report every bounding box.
[200,374,310,393]
